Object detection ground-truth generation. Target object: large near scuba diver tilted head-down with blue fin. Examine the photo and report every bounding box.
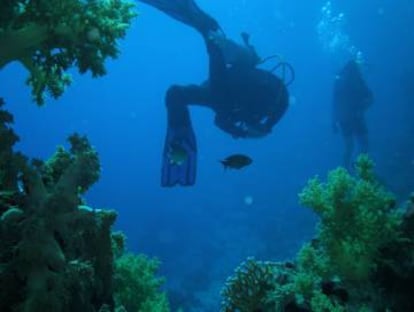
[140,0,293,187]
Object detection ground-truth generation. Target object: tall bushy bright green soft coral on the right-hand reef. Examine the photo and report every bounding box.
[299,155,401,281]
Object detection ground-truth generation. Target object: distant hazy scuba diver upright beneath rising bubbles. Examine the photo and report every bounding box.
[332,60,373,169]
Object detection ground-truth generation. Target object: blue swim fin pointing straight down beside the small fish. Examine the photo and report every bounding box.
[161,126,197,187]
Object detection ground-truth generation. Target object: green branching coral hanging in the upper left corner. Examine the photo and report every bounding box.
[0,0,136,105]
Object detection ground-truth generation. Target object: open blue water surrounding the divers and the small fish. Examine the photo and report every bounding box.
[0,0,414,311]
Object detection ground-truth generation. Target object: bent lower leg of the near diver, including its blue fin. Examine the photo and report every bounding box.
[161,85,209,187]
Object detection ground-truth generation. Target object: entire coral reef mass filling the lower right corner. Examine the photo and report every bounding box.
[222,155,414,312]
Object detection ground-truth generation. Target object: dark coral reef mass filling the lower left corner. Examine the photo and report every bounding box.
[0,100,168,312]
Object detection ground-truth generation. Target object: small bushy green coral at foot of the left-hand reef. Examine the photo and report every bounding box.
[114,254,170,312]
